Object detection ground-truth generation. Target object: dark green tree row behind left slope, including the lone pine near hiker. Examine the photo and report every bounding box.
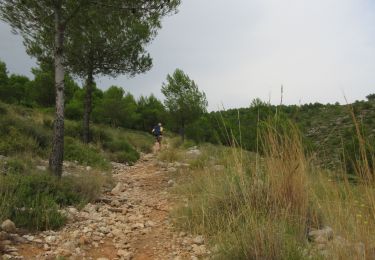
[0,62,212,142]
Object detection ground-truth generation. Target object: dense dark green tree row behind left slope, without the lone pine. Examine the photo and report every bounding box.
[0,62,166,131]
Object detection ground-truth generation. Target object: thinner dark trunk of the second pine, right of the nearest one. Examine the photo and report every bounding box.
[83,70,94,144]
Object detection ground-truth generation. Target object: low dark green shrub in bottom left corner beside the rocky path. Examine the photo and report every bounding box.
[0,174,65,230]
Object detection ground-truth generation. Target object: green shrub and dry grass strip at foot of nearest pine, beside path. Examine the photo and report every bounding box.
[0,169,111,230]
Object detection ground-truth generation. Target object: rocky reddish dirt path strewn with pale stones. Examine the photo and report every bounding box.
[2,154,209,260]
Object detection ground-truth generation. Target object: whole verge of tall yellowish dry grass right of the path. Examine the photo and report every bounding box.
[172,119,375,259]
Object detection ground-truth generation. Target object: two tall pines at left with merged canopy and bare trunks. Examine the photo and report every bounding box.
[0,0,180,176]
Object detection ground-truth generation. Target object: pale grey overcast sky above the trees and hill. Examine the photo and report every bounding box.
[0,0,375,110]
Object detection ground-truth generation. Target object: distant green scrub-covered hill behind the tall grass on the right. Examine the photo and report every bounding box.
[187,95,375,172]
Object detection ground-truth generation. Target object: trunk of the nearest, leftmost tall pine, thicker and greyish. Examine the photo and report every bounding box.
[49,5,65,177]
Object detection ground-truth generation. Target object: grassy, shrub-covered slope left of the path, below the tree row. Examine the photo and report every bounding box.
[0,102,153,230]
